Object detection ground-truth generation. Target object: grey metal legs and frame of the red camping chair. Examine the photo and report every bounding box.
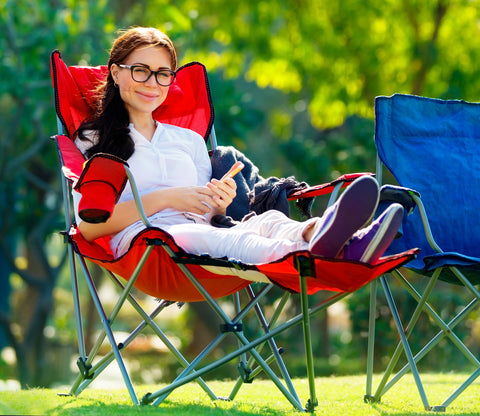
[58,117,358,412]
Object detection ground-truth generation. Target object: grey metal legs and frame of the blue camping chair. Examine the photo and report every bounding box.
[364,156,480,412]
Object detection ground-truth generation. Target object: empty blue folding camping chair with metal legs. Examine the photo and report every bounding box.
[365,94,480,411]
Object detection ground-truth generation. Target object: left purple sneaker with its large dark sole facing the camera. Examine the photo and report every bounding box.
[309,176,379,258]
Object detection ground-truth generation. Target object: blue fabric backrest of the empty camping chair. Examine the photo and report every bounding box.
[375,94,480,269]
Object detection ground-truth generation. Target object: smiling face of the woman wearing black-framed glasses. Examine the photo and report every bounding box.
[111,46,175,123]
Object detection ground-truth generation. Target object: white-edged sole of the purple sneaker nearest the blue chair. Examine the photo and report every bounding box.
[360,204,403,263]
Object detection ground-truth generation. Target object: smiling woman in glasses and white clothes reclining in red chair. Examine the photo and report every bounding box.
[74,27,403,264]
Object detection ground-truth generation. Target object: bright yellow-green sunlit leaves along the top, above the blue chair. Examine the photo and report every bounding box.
[138,0,480,127]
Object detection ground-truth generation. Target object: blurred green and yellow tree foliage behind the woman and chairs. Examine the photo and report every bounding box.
[0,0,480,385]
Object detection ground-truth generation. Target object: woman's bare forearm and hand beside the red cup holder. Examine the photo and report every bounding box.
[78,185,221,241]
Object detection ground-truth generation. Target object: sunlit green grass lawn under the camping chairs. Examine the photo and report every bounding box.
[0,374,480,416]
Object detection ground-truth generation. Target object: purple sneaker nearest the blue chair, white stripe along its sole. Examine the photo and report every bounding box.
[343,204,403,264]
